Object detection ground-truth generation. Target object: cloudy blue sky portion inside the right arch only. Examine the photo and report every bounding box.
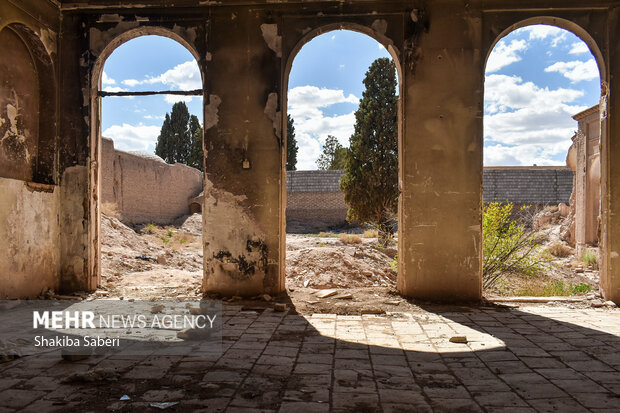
[484,25,600,165]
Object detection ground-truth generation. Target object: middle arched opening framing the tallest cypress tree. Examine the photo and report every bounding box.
[282,24,402,311]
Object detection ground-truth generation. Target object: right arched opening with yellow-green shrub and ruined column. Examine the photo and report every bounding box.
[483,21,605,296]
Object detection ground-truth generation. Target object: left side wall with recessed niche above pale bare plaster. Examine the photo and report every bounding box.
[0,0,69,299]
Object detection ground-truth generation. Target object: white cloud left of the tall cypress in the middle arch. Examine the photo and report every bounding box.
[288,86,359,170]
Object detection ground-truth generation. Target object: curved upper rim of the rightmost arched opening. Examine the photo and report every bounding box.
[484,16,608,83]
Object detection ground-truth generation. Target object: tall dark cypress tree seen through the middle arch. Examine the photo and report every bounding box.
[340,58,398,245]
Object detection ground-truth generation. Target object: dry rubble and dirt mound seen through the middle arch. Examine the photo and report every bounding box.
[286,235,396,289]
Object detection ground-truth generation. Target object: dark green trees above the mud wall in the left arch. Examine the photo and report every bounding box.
[155,102,203,171]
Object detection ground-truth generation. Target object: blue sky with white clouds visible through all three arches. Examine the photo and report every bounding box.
[102,26,600,169]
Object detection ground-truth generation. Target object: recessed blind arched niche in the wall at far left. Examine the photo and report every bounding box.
[0,23,56,184]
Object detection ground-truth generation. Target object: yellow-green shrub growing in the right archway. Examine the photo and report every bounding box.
[482,202,546,288]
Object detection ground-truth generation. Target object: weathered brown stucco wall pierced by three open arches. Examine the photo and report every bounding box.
[0,0,620,302]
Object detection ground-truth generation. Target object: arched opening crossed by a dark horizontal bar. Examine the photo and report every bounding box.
[94,29,204,299]
